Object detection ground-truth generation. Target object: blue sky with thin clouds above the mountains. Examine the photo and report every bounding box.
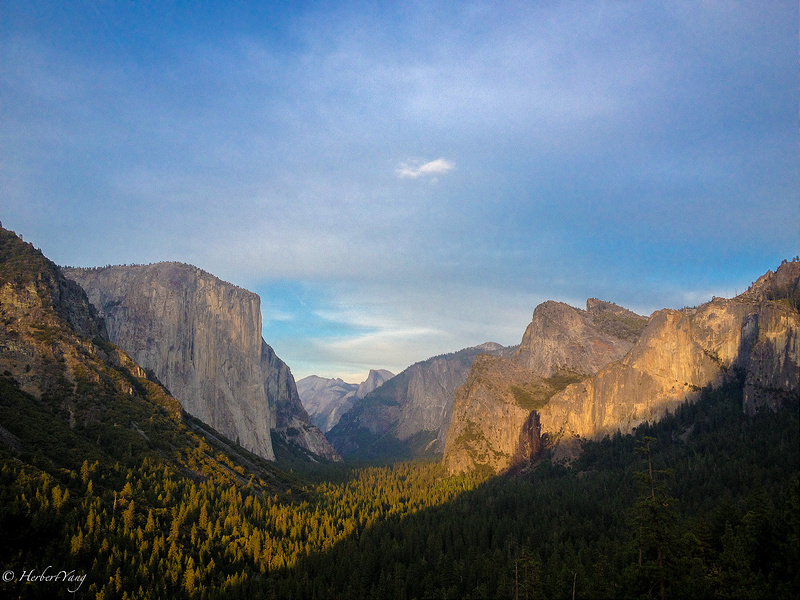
[0,0,800,383]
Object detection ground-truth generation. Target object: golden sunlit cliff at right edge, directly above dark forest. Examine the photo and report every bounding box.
[540,262,800,454]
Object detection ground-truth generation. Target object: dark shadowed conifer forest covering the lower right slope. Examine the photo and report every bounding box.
[242,380,800,598]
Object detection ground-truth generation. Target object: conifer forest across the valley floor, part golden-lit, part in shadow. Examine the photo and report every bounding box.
[0,368,800,598]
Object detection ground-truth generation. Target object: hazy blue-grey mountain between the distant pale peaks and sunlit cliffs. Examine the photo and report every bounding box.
[328,343,516,457]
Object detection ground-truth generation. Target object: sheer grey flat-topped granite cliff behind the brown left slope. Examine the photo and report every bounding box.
[64,263,336,460]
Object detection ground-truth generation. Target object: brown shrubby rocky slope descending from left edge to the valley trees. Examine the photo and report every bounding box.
[0,226,296,492]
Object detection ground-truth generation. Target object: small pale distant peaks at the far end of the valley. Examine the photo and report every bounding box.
[297,369,394,433]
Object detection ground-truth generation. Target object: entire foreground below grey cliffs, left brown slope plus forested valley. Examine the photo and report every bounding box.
[0,224,800,599]
